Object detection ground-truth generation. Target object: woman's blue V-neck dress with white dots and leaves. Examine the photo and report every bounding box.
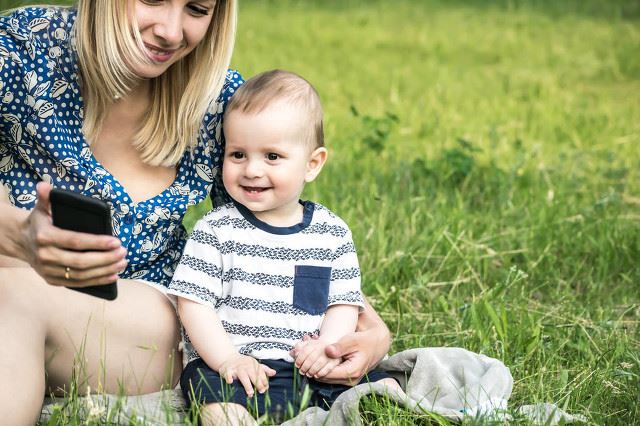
[0,8,242,286]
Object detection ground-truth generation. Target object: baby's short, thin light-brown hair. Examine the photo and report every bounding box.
[225,70,324,149]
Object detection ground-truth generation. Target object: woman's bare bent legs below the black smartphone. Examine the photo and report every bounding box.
[0,268,181,425]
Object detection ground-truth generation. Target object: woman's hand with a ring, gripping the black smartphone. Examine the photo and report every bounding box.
[21,182,127,287]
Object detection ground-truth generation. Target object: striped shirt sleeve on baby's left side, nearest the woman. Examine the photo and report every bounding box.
[168,218,223,309]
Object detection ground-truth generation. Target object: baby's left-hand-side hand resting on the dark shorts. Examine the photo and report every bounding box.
[218,353,276,398]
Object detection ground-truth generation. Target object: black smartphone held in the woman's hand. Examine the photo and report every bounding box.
[50,188,118,300]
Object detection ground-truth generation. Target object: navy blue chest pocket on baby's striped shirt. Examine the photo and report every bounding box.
[293,265,331,315]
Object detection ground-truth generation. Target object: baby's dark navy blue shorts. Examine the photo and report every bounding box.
[180,359,391,418]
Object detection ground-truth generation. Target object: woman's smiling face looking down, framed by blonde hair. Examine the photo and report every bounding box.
[134,0,215,78]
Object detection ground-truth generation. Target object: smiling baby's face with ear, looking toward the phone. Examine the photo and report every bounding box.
[222,102,327,226]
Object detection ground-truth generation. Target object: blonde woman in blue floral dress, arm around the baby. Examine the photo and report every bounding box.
[0,0,389,424]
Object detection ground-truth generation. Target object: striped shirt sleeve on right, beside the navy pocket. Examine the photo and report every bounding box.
[329,225,364,310]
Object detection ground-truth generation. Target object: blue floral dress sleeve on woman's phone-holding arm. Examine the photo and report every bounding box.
[0,7,78,209]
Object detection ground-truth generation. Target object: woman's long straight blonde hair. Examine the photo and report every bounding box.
[75,0,237,166]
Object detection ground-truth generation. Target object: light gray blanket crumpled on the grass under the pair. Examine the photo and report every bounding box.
[41,348,584,426]
